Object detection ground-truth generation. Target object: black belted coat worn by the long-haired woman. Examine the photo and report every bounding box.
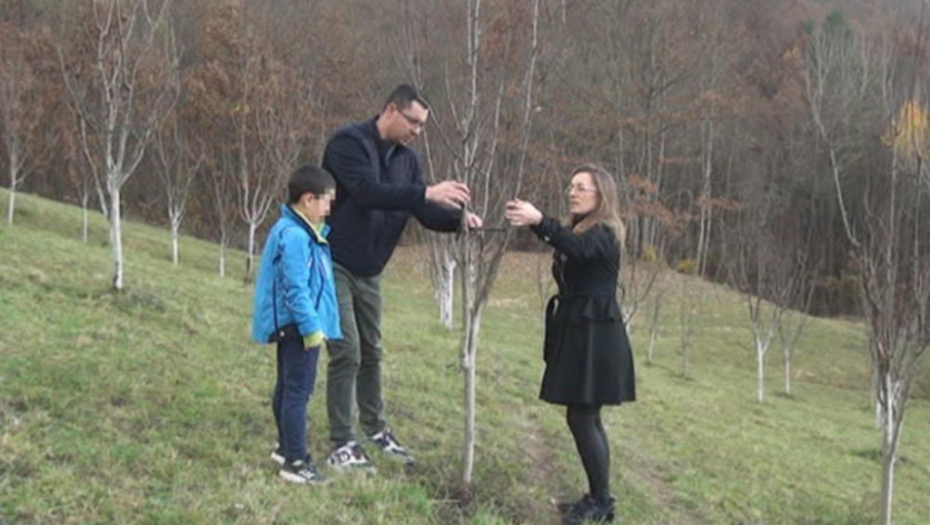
[532,217,636,405]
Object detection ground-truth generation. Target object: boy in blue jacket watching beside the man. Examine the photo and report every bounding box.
[252,166,342,484]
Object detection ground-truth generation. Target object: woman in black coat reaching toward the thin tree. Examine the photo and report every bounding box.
[506,164,636,523]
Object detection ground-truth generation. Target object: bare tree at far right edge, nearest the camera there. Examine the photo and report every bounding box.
[805,9,930,525]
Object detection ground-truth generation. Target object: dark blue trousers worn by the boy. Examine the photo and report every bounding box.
[271,328,320,463]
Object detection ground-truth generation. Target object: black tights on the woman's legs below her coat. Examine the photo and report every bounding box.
[566,405,610,501]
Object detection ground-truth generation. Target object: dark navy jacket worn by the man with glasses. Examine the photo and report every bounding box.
[323,119,462,277]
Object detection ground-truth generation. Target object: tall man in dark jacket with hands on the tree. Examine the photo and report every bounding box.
[323,85,482,471]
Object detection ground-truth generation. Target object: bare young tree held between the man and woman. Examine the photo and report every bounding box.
[434,0,540,487]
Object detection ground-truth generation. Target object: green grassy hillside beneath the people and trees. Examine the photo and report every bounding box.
[0,192,930,525]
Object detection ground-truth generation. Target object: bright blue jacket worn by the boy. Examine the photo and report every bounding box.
[252,205,342,343]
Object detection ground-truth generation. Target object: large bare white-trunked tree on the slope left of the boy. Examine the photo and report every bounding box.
[58,0,179,290]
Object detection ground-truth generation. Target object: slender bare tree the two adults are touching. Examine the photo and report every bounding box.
[436,0,540,486]
